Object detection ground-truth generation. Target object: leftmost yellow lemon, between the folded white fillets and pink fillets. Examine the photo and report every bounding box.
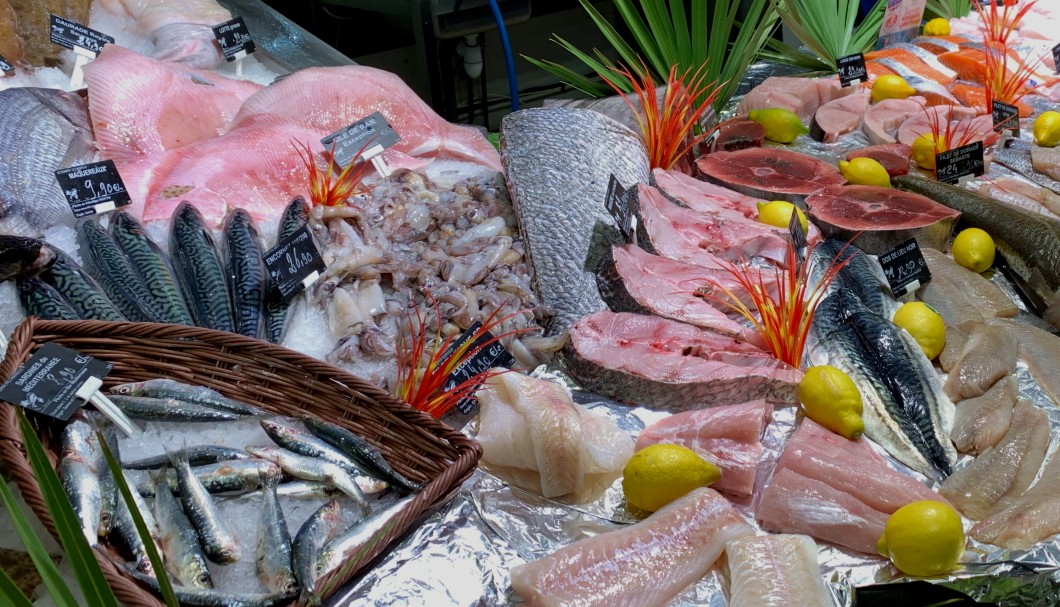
[622,443,722,512]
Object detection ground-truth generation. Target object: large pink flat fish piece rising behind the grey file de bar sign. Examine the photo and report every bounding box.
[236,66,501,171]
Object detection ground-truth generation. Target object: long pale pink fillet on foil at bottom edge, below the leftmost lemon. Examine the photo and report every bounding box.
[511,487,755,607]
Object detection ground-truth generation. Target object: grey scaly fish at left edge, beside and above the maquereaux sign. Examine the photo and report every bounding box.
[0,87,95,236]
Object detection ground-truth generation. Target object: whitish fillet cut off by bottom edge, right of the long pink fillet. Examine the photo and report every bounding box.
[725,535,835,607]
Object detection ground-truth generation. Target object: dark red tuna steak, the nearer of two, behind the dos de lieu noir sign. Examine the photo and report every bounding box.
[806,185,960,255]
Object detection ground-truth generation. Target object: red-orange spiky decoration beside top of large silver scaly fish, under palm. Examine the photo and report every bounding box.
[603,63,721,171]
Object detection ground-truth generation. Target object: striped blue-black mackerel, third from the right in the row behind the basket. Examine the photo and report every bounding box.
[170,202,235,333]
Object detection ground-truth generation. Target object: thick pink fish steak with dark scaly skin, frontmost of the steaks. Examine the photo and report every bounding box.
[565,311,802,411]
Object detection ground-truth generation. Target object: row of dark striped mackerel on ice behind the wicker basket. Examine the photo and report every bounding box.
[0,198,308,343]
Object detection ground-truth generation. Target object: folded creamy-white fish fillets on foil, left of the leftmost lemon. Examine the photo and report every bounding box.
[476,373,633,498]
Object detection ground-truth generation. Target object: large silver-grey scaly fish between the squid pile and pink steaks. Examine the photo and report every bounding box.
[500,108,650,335]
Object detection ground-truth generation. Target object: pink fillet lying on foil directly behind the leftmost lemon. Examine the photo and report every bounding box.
[636,400,773,496]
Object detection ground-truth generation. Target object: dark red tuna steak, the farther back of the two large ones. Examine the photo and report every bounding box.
[696,147,844,204]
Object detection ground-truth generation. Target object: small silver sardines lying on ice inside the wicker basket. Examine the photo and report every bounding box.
[58,379,419,607]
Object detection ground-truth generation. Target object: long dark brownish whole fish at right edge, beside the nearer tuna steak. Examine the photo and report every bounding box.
[891,175,1060,302]
